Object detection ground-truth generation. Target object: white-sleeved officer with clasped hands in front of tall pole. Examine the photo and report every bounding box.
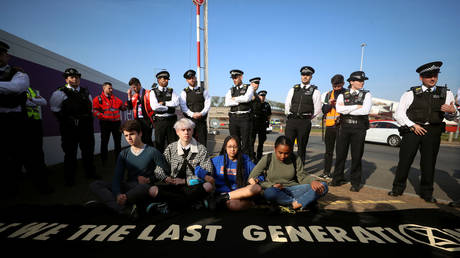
[179,70,211,146]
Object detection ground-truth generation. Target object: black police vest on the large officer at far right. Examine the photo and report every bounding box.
[406,86,447,124]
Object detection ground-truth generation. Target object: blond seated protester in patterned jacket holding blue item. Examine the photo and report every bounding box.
[147,118,214,212]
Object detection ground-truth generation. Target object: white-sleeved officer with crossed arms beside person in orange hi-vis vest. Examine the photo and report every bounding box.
[329,71,372,192]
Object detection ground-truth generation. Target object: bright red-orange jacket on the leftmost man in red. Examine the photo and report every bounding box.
[93,93,125,121]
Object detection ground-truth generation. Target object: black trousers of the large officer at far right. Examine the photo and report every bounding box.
[393,125,443,198]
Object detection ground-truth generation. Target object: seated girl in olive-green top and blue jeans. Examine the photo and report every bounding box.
[249,135,328,210]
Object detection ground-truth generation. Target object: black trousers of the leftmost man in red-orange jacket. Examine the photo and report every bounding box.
[99,120,121,163]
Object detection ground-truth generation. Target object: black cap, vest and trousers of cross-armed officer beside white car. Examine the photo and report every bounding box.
[330,72,370,192]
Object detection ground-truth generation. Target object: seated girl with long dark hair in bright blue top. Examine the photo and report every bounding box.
[211,136,262,211]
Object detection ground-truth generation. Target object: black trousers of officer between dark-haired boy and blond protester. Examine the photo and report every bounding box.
[155,116,178,153]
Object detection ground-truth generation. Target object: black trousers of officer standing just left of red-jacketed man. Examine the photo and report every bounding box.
[59,118,95,185]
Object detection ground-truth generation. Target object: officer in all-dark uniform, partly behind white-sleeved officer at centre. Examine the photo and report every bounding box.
[252,90,272,161]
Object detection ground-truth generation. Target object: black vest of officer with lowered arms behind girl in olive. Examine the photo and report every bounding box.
[289,84,318,115]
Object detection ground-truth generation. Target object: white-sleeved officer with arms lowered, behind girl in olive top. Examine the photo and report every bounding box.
[284,66,321,163]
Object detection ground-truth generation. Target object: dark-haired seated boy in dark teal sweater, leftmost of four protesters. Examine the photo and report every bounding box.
[90,120,168,215]
